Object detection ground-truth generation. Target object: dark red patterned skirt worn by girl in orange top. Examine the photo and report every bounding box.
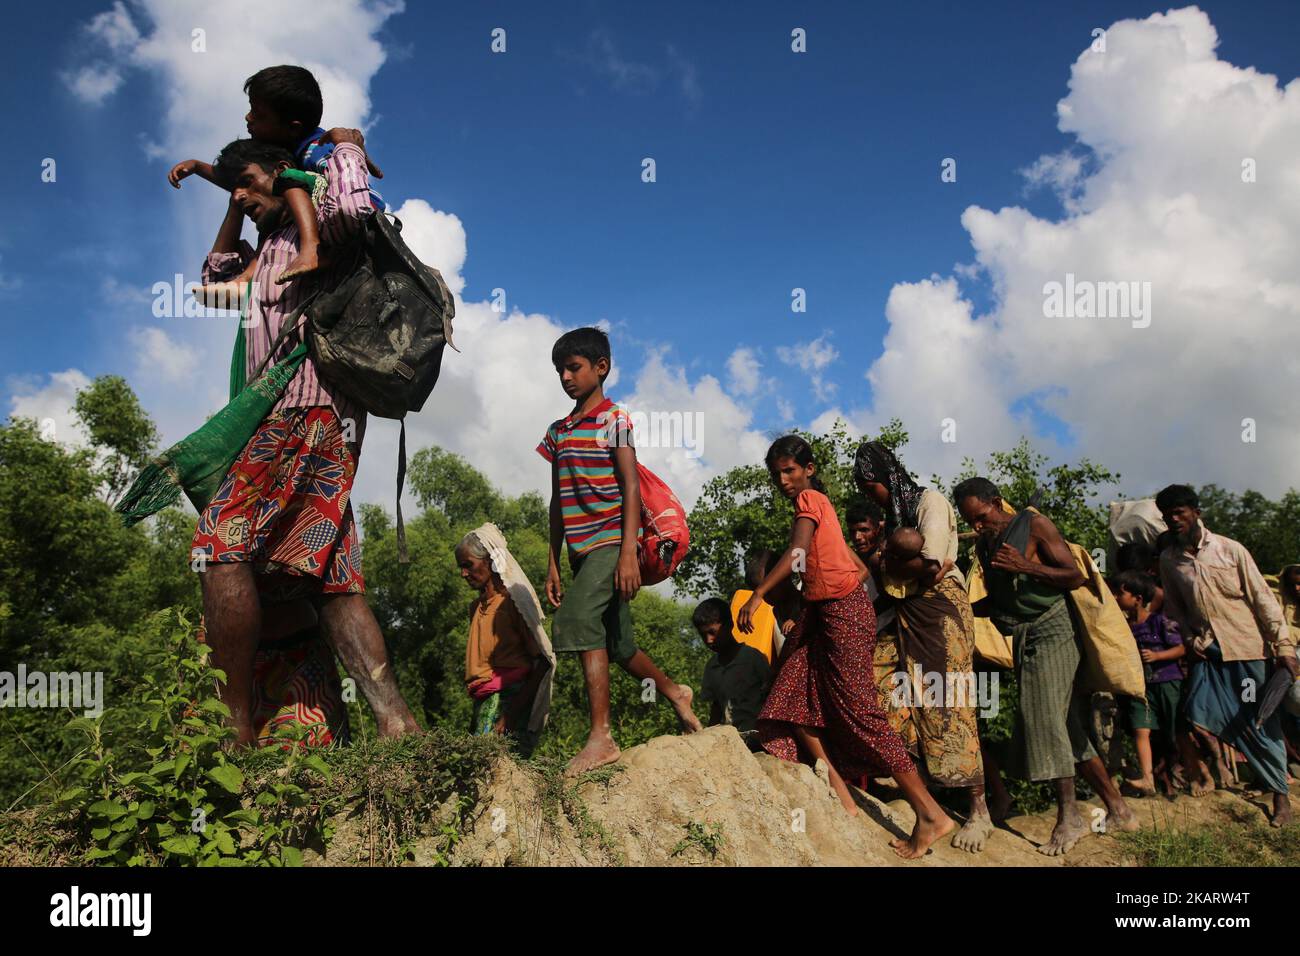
[758,589,915,779]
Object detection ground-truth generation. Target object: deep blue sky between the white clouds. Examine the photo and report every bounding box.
[0,1,1300,509]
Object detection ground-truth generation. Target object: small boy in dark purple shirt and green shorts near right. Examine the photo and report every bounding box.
[1110,568,1188,796]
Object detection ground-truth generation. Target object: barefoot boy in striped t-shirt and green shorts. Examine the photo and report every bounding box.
[537,328,701,774]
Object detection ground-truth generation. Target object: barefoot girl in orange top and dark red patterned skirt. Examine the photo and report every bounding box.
[736,434,957,860]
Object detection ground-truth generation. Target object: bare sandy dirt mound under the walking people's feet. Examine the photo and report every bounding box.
[431,727,1284,866]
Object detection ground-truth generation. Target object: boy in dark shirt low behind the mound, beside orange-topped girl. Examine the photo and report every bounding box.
[690,597,772,749]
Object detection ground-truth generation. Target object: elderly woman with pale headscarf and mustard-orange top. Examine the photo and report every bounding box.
[456,522,555,756]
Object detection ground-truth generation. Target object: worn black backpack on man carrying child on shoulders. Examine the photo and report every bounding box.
[254,211,456,562]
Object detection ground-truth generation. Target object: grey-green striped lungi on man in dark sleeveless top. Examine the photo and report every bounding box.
[995,596,1097,780]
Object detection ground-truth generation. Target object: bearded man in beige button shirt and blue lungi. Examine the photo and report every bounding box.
[1156,485,1300,827]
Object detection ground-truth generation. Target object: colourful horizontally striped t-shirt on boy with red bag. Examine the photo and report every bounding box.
[537,398,642,558]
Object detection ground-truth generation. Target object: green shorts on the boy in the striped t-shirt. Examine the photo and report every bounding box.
[551,545,637,663]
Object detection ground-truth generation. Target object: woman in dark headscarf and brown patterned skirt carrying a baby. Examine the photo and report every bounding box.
[853,441,993,853]
